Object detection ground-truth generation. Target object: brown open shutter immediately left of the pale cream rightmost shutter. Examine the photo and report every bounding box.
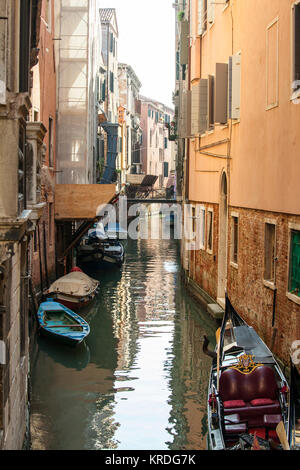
[214,63,228,124]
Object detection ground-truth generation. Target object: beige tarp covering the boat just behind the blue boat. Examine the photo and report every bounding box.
[48,271,99,296]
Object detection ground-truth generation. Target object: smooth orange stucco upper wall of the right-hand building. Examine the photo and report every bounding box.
[189,0,300,214]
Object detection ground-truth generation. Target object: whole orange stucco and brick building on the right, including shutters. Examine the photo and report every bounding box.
[177,0,300,362]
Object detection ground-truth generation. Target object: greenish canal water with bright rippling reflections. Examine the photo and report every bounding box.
[31,218,216,450]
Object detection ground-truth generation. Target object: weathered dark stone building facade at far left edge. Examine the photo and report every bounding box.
[0,0,46,450]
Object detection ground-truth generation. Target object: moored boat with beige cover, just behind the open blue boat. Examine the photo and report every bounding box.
[46,267,99,310]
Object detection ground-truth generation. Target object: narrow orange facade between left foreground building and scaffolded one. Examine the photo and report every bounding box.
[28,0,56,297]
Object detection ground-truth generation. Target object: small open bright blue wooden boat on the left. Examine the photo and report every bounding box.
[37,298,90,346]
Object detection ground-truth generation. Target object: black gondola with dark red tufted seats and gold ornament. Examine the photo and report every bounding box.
[203,295,290,450]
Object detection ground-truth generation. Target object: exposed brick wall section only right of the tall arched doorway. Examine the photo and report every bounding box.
[227,208,300,362]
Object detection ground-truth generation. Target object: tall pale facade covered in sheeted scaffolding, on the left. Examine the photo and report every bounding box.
[55,0,101,184]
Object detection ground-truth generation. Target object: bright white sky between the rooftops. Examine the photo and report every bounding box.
[100,0,175,108]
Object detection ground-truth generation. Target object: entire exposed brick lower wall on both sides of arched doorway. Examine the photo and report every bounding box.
[188,203,300,363]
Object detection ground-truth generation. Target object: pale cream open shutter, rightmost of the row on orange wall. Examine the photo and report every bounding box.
[228,54,241,119]
